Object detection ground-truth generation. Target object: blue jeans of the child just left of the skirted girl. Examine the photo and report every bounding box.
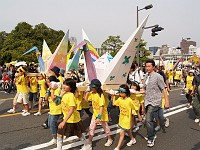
[48,114,60,137]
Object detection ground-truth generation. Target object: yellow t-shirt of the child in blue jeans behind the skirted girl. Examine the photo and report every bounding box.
[48,88,62,115]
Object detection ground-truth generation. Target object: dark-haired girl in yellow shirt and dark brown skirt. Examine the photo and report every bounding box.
[57,78,86,150]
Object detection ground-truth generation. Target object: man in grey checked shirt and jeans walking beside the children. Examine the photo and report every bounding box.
[136,59,169,147]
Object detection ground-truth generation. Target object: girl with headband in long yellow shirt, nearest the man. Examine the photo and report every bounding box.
[113,84,136,150]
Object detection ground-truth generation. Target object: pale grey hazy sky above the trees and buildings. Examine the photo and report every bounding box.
[0,0,200,48]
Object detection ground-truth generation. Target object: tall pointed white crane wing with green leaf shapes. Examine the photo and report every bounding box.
[98,16,148,85]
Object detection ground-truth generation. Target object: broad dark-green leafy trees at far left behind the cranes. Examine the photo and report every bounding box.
[0,22,64,65]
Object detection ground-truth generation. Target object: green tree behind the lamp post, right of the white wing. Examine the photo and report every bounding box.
[134,39,151,63]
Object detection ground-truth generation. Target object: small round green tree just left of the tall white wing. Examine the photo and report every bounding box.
[101,35,124,56]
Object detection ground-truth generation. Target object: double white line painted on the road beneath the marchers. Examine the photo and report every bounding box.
[21,104,190,150]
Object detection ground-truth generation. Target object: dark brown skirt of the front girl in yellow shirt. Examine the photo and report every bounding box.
[57,120,85,138]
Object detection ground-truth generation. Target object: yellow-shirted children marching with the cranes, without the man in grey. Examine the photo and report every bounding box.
[3,61,200,150]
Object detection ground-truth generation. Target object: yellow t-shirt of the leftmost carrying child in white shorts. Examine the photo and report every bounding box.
[17,75,29,94]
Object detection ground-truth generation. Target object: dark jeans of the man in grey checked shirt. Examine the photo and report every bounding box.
[146,105,160,141]
